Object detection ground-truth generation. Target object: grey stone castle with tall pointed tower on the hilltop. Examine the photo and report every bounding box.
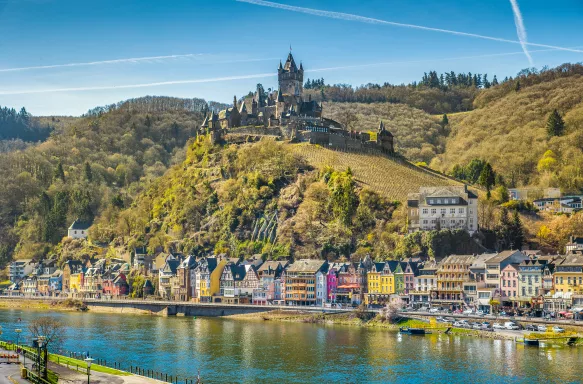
[200,52,394,154]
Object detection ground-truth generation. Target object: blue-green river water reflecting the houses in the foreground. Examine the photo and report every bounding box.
[0,310,583,383]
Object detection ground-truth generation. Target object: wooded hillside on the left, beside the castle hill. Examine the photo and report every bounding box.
[0,98,206,260]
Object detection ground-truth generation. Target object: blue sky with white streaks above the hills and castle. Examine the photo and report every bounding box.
[0,0,583,116]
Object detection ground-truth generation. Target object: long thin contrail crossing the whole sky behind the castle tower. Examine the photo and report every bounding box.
[0,46,581,96]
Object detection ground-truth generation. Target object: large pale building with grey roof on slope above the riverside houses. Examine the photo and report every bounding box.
[407,185,478,235]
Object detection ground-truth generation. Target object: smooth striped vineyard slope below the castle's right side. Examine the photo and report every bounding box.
[290,144,459,201]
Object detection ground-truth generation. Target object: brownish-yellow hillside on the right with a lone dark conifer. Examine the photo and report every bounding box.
[431,65,583,192]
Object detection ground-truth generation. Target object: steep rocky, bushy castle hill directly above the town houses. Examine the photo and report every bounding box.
[90,137,476,259]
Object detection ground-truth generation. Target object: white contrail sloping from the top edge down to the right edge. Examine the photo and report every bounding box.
[235,0,583,53]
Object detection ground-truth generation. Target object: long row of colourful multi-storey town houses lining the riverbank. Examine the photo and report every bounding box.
[4,218,583,318]
